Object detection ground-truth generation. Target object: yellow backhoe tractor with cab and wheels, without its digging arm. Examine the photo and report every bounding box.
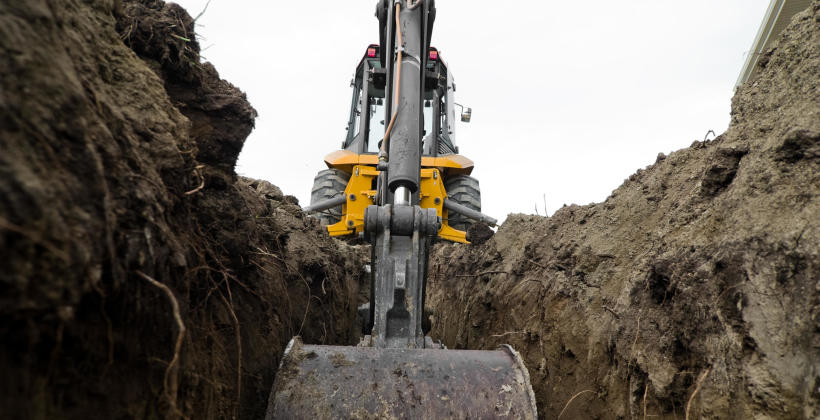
[305,4,496,243]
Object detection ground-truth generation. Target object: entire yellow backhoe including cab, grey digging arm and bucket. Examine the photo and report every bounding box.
[266,0,538,420]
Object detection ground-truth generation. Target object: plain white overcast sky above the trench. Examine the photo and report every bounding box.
[171,0,769,220]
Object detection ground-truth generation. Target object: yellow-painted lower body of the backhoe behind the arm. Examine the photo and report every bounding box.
[325,150,473,243]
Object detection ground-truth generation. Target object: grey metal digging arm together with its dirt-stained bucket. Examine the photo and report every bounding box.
[267,0,537,419]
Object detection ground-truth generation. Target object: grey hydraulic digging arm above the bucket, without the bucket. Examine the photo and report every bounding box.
[365,0,441,348]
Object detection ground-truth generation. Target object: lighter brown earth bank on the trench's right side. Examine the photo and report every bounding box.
[428,1,820,419]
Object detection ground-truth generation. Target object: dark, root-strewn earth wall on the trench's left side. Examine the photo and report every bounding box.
[0,0,362,419]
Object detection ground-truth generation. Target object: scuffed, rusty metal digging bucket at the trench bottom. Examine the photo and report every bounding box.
[266,339,537,420]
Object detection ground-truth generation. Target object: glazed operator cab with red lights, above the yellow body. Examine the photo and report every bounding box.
[342,44,464,156]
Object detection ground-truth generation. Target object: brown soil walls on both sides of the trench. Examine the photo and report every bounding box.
[0,0,820,419]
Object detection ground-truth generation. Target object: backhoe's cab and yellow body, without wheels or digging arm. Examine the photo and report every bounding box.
[325,44,474,243]
